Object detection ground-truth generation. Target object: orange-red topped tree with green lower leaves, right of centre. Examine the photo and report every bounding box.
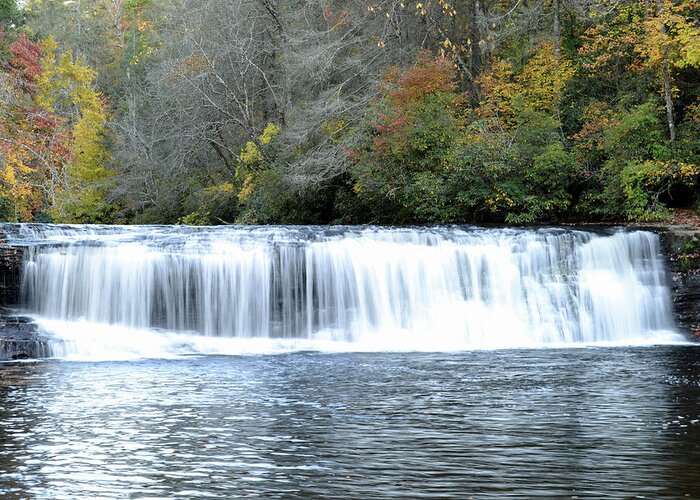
[351,52,464,222]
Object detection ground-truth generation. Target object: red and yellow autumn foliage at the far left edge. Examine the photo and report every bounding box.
[0,27,109,222]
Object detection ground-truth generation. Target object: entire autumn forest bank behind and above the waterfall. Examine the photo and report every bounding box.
[0,0,700,225]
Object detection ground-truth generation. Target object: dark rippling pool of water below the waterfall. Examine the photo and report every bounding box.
[0,346,700,499]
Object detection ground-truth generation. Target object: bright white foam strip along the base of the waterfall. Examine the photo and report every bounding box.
[30,317,690,361]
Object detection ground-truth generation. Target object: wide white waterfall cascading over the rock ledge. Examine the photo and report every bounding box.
[4,225,679,355]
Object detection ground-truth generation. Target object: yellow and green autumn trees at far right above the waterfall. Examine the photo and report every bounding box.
[573,1,700,219]
